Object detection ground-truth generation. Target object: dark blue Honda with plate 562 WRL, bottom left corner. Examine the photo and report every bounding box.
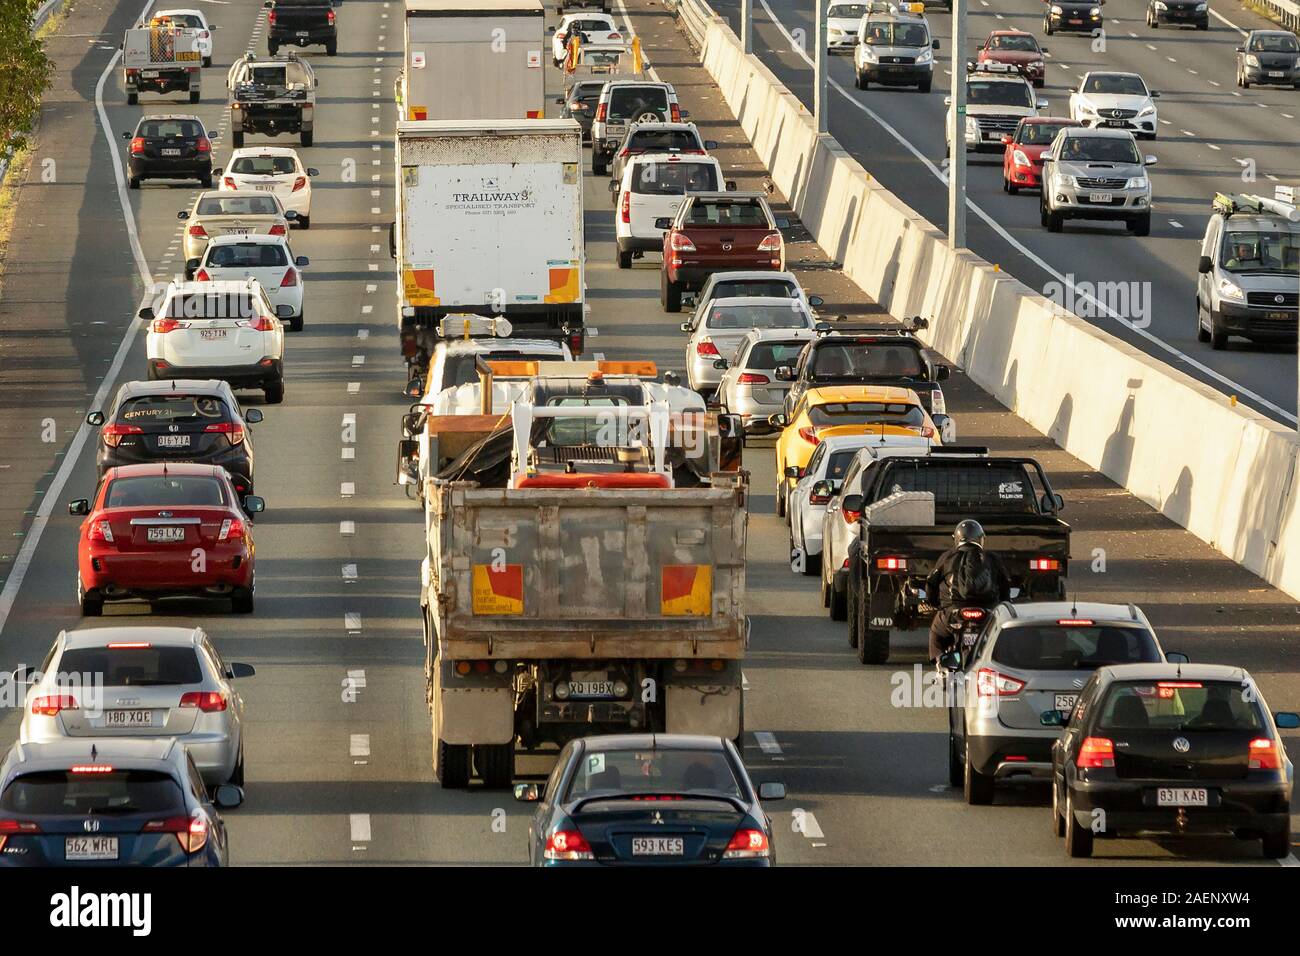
[0,737,243,866]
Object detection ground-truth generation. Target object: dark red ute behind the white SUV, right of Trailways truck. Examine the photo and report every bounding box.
[655,193,785,312]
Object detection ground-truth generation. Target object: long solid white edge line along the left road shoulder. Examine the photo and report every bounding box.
[0,0,153,647]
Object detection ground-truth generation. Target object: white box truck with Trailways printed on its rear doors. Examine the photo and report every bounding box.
[389,120,586,373]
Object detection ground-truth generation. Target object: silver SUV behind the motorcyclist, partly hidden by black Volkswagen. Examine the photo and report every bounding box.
[939,601,1187,804]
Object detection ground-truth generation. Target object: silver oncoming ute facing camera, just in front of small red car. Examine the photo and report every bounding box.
[1039,126,1156,235]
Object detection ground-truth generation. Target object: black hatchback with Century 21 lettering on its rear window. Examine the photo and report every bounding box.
[86,378,261,496]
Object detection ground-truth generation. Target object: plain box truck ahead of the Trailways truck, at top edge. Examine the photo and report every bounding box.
[398,0,549,120]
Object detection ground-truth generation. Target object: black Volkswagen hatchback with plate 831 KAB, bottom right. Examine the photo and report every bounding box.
[1041,663,1300,860]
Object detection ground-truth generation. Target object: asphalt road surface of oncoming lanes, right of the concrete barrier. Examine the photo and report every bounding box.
[714,0,1300,423]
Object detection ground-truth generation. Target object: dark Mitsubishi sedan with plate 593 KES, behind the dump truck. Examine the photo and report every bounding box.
[515,734,785,866]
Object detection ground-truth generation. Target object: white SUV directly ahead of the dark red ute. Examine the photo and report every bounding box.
[610,152,736,269]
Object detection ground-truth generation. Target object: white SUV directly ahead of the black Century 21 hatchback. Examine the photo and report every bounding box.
[139,278,293,405]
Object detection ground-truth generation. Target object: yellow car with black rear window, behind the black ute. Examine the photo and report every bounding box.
[768,385,943,518]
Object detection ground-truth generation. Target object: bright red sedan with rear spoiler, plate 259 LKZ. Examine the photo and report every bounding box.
[68,463,267,615]
